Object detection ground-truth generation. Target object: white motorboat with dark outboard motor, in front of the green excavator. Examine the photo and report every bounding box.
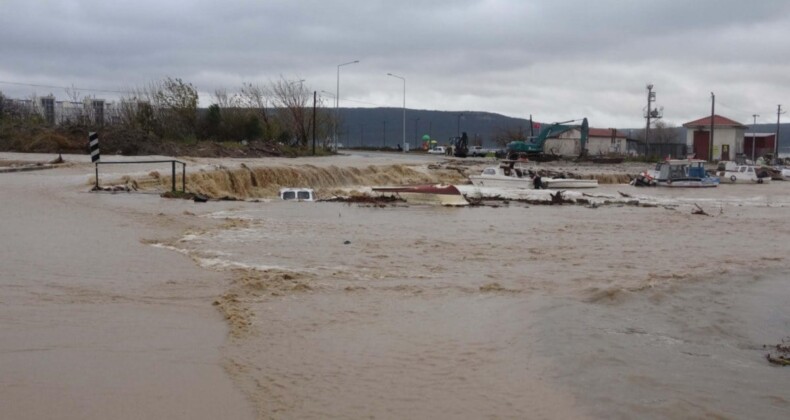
[469,160,598,189]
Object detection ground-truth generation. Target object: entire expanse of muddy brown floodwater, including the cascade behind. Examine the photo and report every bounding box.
[6,156,790,419]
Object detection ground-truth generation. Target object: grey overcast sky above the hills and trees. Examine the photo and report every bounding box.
[0,0,790,128]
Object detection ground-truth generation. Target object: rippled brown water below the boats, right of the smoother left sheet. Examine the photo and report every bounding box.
[155,183,790,419]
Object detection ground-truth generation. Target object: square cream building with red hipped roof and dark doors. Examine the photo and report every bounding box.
[683,115,746,161]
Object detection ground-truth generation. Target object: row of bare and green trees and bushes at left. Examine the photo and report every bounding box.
[0,77,336,153]
